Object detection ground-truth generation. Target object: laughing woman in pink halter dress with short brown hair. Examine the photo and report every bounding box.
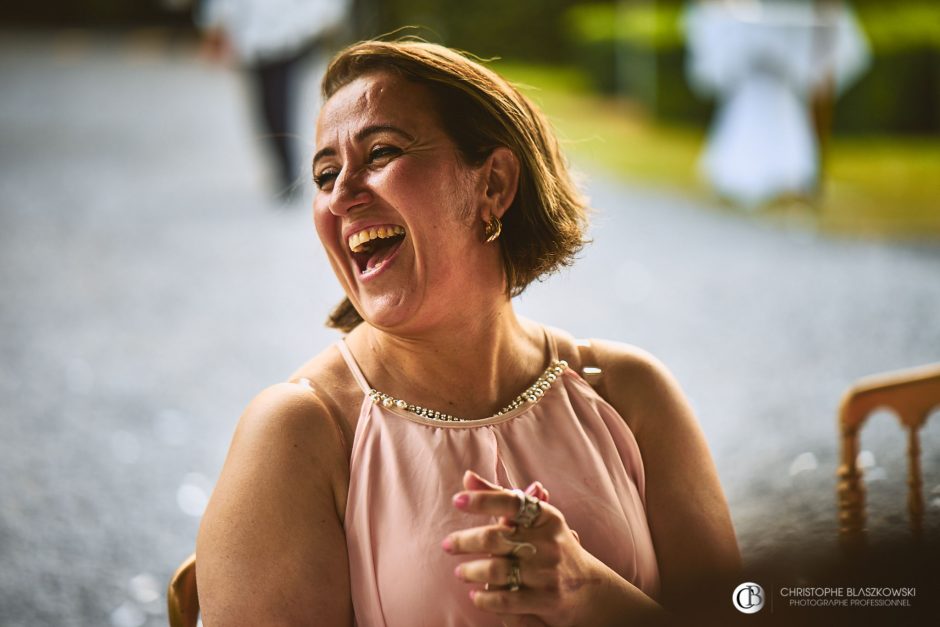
[197,42,739,627]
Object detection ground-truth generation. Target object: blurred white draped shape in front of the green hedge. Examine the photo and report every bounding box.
[684,0,869,209]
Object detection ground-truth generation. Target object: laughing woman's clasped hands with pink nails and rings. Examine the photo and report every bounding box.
[442,471,617,626]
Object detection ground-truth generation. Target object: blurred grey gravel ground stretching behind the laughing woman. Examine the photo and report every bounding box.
[0,34,940,627]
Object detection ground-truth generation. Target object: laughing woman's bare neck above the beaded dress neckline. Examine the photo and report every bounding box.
[348,299,547,419]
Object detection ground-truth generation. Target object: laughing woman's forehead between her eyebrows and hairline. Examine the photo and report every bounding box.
[317,72,436,143]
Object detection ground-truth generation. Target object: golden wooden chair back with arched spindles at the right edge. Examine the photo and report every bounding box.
[838,363,940,548]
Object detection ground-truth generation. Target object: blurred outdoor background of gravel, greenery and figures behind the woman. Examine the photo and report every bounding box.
[0,0,940,627]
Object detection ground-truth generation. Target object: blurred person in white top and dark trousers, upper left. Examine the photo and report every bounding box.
[196,0,351,194]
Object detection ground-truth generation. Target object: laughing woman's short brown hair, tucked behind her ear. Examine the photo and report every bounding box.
[322,41,587,331]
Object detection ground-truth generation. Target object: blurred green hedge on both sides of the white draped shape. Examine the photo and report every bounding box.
[565,0,940,134]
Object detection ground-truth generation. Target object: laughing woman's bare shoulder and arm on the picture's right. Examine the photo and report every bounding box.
[592,341,741,610]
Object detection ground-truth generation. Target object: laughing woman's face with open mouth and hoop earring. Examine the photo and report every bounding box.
[313,72,502,328]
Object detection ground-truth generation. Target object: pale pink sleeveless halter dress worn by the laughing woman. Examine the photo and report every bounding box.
[338,336,659,627]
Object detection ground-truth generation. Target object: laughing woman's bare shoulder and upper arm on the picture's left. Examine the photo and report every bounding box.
[196,383,352,627]
